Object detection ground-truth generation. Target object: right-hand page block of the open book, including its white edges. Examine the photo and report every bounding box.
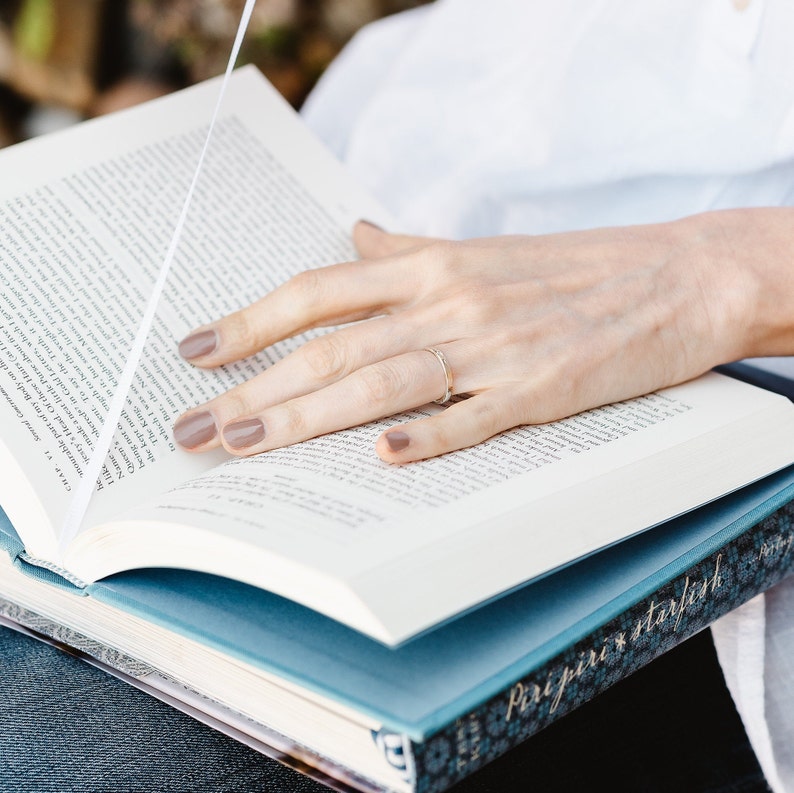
[69,374,794,642]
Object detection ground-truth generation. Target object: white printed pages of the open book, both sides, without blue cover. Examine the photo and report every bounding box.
[0,69,794,645]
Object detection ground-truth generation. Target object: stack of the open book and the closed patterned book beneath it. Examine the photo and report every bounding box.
[0,69,794,791]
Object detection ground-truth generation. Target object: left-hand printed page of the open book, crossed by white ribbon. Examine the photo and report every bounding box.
[0,72,386,556]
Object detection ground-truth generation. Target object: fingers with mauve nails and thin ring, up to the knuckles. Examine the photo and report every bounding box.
[174,222,544,463]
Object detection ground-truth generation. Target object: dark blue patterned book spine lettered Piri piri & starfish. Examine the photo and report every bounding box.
[411,504,794,793]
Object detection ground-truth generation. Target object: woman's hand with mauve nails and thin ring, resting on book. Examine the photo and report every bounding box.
[174,210,794,463]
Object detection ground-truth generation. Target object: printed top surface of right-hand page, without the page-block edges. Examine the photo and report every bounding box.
[80,376,772,577]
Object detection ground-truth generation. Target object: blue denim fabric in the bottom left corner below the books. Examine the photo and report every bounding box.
[0,628,327,793]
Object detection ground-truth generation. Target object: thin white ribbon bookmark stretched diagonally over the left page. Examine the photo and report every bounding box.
[59,0,256,551]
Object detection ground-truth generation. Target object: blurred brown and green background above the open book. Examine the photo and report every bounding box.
[0,0,427,146]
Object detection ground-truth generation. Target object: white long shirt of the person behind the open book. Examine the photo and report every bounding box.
[304,0,794,793]
